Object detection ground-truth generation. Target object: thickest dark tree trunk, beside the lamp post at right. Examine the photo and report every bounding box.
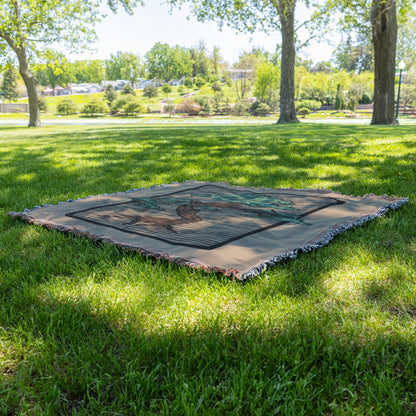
[371,0,397,124]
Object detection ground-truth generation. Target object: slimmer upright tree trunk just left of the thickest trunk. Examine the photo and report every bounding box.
[278,0,299,124]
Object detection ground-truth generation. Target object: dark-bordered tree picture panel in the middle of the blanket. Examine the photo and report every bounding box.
[66,185,345,250]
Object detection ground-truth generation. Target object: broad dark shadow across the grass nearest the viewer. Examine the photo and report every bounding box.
[0,263,416,415]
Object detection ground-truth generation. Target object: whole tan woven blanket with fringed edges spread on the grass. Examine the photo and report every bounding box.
[8,181,408,280]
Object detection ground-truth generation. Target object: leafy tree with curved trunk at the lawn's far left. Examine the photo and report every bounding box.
[0,0,141,127]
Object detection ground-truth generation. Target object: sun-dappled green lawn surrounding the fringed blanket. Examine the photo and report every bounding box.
[0,124,416,416]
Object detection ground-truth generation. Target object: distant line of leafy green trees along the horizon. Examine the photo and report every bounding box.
[4,5,416,92]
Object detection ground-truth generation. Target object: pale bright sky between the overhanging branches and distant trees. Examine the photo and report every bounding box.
[65,1,336,63]
